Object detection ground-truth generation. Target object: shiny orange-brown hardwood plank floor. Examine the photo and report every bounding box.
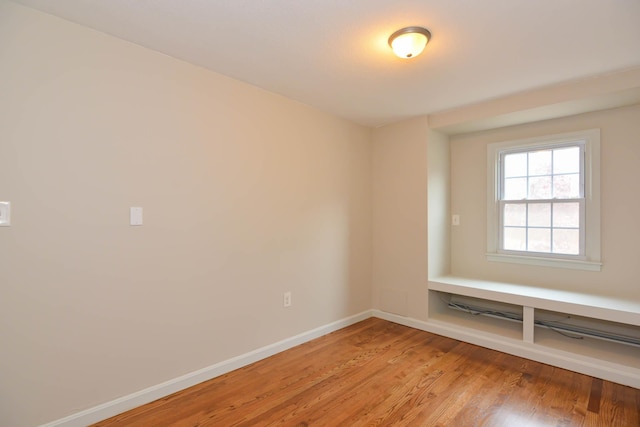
[95,318,640,427]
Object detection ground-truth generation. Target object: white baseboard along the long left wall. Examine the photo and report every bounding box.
[41,310,373,427]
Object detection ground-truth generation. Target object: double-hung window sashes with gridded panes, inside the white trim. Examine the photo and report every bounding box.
[498,141,585,257]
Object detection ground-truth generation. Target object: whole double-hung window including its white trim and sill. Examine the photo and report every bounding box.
[487,129,601,271]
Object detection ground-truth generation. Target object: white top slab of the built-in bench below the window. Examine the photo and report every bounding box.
[429,276,640,326]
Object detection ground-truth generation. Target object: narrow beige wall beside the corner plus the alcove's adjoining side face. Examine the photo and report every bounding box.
[372,123,450,320]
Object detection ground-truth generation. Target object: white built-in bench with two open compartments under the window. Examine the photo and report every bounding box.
[427,276,640,388]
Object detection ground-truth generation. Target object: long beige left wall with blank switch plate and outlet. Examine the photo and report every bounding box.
[0,0,372,426]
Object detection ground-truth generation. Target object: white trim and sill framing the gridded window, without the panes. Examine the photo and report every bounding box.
[487,129,602,271]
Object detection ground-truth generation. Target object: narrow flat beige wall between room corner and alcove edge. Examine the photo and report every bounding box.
[372,117,429,320]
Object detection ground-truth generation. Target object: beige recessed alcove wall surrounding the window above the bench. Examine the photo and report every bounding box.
[450,105,640,298]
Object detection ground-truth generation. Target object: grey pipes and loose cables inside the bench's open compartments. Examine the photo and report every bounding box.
[445,295,640,347]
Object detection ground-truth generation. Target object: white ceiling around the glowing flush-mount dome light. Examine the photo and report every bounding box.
[8,0,640,126]
